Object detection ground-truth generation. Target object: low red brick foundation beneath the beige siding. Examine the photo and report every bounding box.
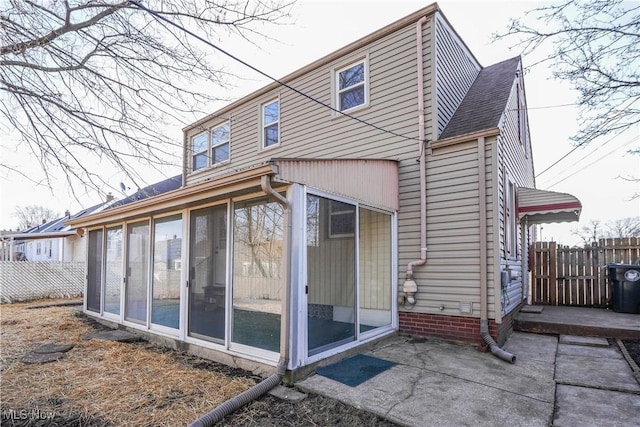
[399,309,518,346]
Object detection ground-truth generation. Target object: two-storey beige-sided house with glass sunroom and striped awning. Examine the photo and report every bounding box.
[68,4,581,378]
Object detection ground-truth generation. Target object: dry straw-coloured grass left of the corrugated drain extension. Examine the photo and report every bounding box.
[0,302,255,426]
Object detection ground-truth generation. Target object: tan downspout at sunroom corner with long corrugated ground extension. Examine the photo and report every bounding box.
[189,175,292,427]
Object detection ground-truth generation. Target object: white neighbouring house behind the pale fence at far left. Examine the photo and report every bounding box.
[0,200,113,262]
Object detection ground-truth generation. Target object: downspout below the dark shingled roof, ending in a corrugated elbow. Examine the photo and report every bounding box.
[478,137,516,363]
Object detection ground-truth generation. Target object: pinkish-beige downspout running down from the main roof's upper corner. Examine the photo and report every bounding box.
[402,16,427,305]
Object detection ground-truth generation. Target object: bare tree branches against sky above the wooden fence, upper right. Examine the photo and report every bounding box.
[494,0,640,145]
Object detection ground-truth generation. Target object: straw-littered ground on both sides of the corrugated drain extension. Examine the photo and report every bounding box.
[0,303,396,427]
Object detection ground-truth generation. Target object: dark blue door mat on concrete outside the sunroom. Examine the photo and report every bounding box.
[316,354,395,387]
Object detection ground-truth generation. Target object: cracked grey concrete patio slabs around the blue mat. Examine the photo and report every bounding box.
[296,332,640,427]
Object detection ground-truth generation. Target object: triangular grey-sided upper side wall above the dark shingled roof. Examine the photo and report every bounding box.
[435,15,480,136]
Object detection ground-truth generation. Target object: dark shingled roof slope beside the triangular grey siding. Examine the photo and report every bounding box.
[439,56,520,139]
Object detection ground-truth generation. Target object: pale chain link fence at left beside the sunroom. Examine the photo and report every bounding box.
[0,261,85,303]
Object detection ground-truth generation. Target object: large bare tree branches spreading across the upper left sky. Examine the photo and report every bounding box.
[0,0,291,194]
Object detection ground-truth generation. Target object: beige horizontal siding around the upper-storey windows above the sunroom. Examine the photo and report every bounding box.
[186,17,434,308]
